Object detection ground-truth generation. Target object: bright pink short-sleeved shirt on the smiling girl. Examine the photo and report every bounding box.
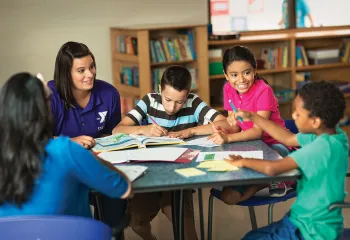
[224,79,285,145]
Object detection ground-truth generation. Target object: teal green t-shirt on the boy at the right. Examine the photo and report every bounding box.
[289,128,349,240]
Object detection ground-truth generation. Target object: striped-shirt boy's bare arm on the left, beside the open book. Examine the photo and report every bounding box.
[112,116,168,137]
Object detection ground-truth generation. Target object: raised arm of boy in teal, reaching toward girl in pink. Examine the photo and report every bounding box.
[235,110,300,147]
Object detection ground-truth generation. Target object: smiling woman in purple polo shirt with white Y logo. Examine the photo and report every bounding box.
[48,42,127,238]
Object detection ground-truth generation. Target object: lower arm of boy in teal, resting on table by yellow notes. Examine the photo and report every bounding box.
[226,155,298,176]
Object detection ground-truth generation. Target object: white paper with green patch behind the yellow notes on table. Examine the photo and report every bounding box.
[196,151,264,162]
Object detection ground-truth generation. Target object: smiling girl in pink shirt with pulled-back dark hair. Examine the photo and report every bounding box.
[209,46,289,205]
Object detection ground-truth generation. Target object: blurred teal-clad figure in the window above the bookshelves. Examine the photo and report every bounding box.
[282,0,310,28]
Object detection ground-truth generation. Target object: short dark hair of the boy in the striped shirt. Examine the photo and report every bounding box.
[160,65,192,92]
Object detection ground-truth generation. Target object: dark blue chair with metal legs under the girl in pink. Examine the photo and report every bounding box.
[208,120,298,240]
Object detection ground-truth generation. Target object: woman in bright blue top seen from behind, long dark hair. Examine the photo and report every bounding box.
[0,73,131,217]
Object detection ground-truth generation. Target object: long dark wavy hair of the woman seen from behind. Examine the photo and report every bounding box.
[0,73,53,207]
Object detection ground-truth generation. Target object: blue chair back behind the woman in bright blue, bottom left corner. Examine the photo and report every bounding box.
[0,216,112,240]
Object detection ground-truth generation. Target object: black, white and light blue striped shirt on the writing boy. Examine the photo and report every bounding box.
[126,93,220,132]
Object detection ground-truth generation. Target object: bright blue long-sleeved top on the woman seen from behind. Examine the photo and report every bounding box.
[0,137,128,217]
